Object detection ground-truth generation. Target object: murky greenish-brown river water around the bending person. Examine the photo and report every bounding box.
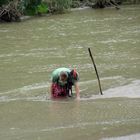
[0,6,140,140]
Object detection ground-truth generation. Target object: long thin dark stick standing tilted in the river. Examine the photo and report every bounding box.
[88,48,103,95]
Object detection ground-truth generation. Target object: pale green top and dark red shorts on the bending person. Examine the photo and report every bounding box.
[51,68,79,97]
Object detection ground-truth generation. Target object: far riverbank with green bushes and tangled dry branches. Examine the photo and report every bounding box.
[0,0,139,22]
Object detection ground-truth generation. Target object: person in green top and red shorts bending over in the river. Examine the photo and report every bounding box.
[51,68,80,99]
